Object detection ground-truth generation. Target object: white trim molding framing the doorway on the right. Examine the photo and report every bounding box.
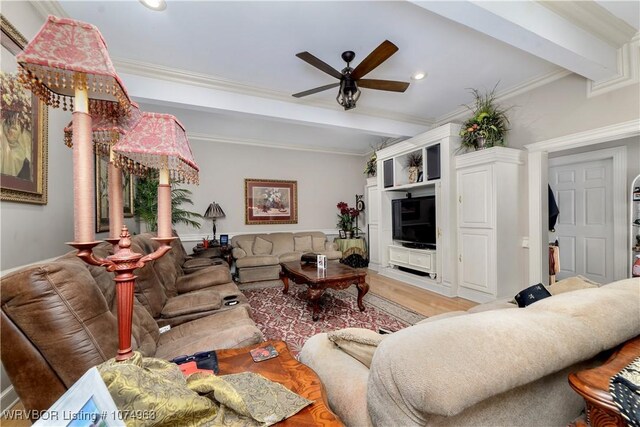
[524,119,640,283]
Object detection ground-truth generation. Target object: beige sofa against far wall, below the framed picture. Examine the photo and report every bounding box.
[231,231,342,283]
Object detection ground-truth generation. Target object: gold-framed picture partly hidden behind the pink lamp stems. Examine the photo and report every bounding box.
[95,154,134,233]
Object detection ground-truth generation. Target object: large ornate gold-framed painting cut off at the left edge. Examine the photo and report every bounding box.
[0,15,48,205]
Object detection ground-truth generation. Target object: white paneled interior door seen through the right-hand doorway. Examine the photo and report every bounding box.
[549,159,615,283]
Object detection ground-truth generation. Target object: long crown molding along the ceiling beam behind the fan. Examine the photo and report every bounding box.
[113,58,433,126]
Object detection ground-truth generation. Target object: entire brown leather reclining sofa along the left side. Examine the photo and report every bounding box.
[0,235,264,418]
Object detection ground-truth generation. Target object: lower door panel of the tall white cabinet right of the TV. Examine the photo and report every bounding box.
[458,228,496,294]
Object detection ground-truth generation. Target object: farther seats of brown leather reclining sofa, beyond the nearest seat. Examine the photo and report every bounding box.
[131,233,250,326]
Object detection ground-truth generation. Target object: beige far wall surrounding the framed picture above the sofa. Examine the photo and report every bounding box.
[176,139,366,242]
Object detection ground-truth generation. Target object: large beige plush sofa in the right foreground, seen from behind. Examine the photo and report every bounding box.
[300,278,640,426]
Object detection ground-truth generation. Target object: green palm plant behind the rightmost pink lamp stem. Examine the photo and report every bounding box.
[133,177,203,231]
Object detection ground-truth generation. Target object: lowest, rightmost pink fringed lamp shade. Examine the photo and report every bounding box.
[113,112,200,184]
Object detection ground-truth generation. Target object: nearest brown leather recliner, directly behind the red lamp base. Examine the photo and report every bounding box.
[0,251,264,418]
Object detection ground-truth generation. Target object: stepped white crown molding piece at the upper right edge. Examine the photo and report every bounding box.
[587,33,640,98]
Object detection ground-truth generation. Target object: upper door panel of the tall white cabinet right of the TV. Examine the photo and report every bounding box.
[457,165,494,228]
